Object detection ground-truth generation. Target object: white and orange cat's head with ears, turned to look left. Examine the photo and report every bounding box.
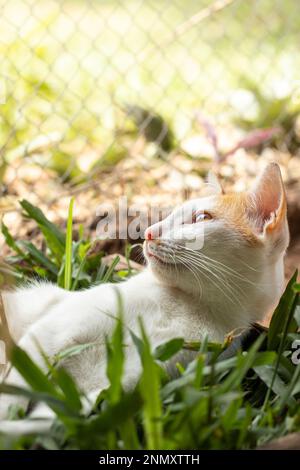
[144,163,289,326]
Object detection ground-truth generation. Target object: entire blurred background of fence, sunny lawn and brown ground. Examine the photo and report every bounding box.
[0,0,300,273]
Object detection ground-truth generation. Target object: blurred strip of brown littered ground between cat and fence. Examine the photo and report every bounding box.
[0,144,300,278]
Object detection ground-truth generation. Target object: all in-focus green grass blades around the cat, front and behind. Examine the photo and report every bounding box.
[0,197,300,449]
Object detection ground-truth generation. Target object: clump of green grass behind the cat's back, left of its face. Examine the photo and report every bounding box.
[1,200,131,290]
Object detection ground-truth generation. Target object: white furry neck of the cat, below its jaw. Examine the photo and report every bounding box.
[117,268,248,341]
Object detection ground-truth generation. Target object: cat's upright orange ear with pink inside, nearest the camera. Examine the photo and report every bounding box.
[248,163,287,234]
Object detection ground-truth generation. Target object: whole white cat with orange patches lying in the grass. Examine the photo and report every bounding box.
[0,163,289,419]
